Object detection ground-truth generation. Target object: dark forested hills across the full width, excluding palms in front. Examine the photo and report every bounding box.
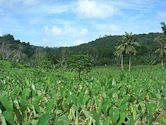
[0,33,161,65]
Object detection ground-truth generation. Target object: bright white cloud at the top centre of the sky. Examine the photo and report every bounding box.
[76,0,118,18]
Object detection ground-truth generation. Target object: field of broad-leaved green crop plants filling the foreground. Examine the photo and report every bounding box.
[0,66,166,125]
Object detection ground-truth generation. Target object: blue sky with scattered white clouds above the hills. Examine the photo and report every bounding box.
[0,0,166,47]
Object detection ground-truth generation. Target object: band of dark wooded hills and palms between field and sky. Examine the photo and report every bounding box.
[0,22,166,70]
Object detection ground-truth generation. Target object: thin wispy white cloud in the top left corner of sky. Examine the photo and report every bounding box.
[0,0,70,16]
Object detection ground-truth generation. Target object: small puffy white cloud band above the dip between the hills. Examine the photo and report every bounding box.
[44,25,88,38]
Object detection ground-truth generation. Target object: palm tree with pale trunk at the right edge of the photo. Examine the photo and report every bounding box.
[155,35,166,69]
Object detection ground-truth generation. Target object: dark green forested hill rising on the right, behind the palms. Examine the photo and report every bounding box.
[64,33,161,65]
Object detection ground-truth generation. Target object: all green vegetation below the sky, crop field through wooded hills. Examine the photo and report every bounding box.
[0,23,166,125]
